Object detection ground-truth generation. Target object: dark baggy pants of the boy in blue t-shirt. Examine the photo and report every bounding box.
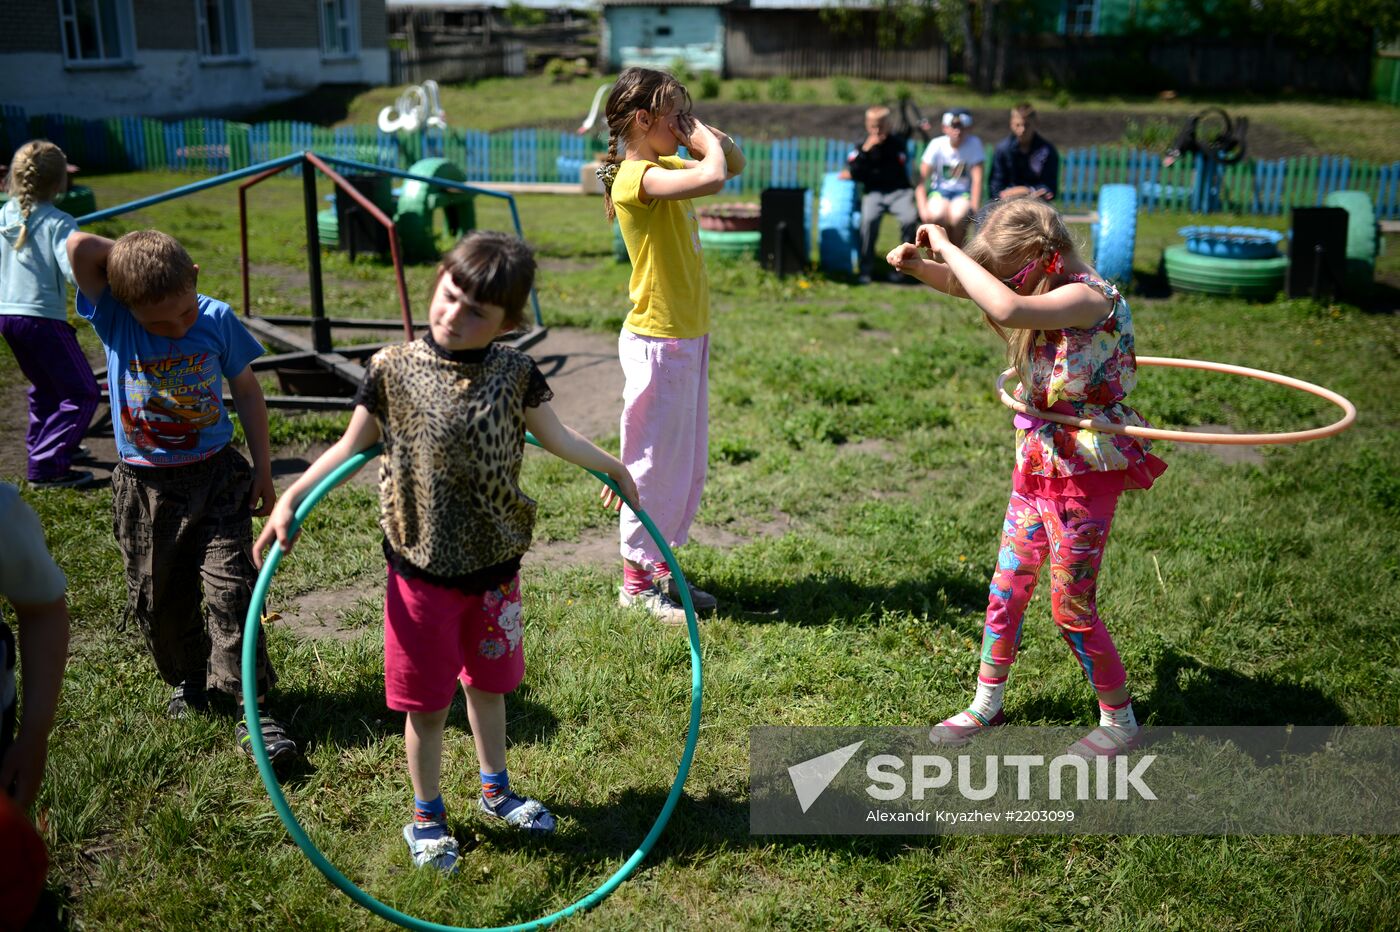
[112,446,276,696]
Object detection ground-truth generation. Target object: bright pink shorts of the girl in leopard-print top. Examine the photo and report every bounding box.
[384,567,525,712]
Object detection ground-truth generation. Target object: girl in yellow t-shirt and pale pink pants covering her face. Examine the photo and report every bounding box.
[598,69,745,624]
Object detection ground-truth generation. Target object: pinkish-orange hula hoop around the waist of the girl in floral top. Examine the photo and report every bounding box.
[997,355,1357,446]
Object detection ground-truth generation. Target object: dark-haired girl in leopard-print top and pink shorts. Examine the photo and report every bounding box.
[255,232,637,872]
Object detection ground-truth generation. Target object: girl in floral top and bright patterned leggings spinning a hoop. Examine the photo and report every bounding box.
[889,199,1166,757]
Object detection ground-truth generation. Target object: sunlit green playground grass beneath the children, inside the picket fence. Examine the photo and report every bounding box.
[0,175,1400,929]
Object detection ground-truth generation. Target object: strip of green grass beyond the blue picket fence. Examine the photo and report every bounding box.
[320,76,1397,162]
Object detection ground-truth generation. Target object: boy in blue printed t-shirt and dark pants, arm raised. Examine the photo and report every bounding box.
[69,230,297,761]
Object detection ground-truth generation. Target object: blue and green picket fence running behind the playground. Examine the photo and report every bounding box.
[0,105,1400,218]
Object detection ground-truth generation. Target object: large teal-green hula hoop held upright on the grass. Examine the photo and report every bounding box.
[242,434,700,932]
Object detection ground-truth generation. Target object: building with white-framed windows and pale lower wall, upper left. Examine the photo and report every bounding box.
[0,0,389,118]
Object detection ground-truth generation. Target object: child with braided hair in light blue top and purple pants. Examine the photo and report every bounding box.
[0,140,99,488]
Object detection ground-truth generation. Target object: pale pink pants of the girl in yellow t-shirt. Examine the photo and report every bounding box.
[617,330,710,567]
